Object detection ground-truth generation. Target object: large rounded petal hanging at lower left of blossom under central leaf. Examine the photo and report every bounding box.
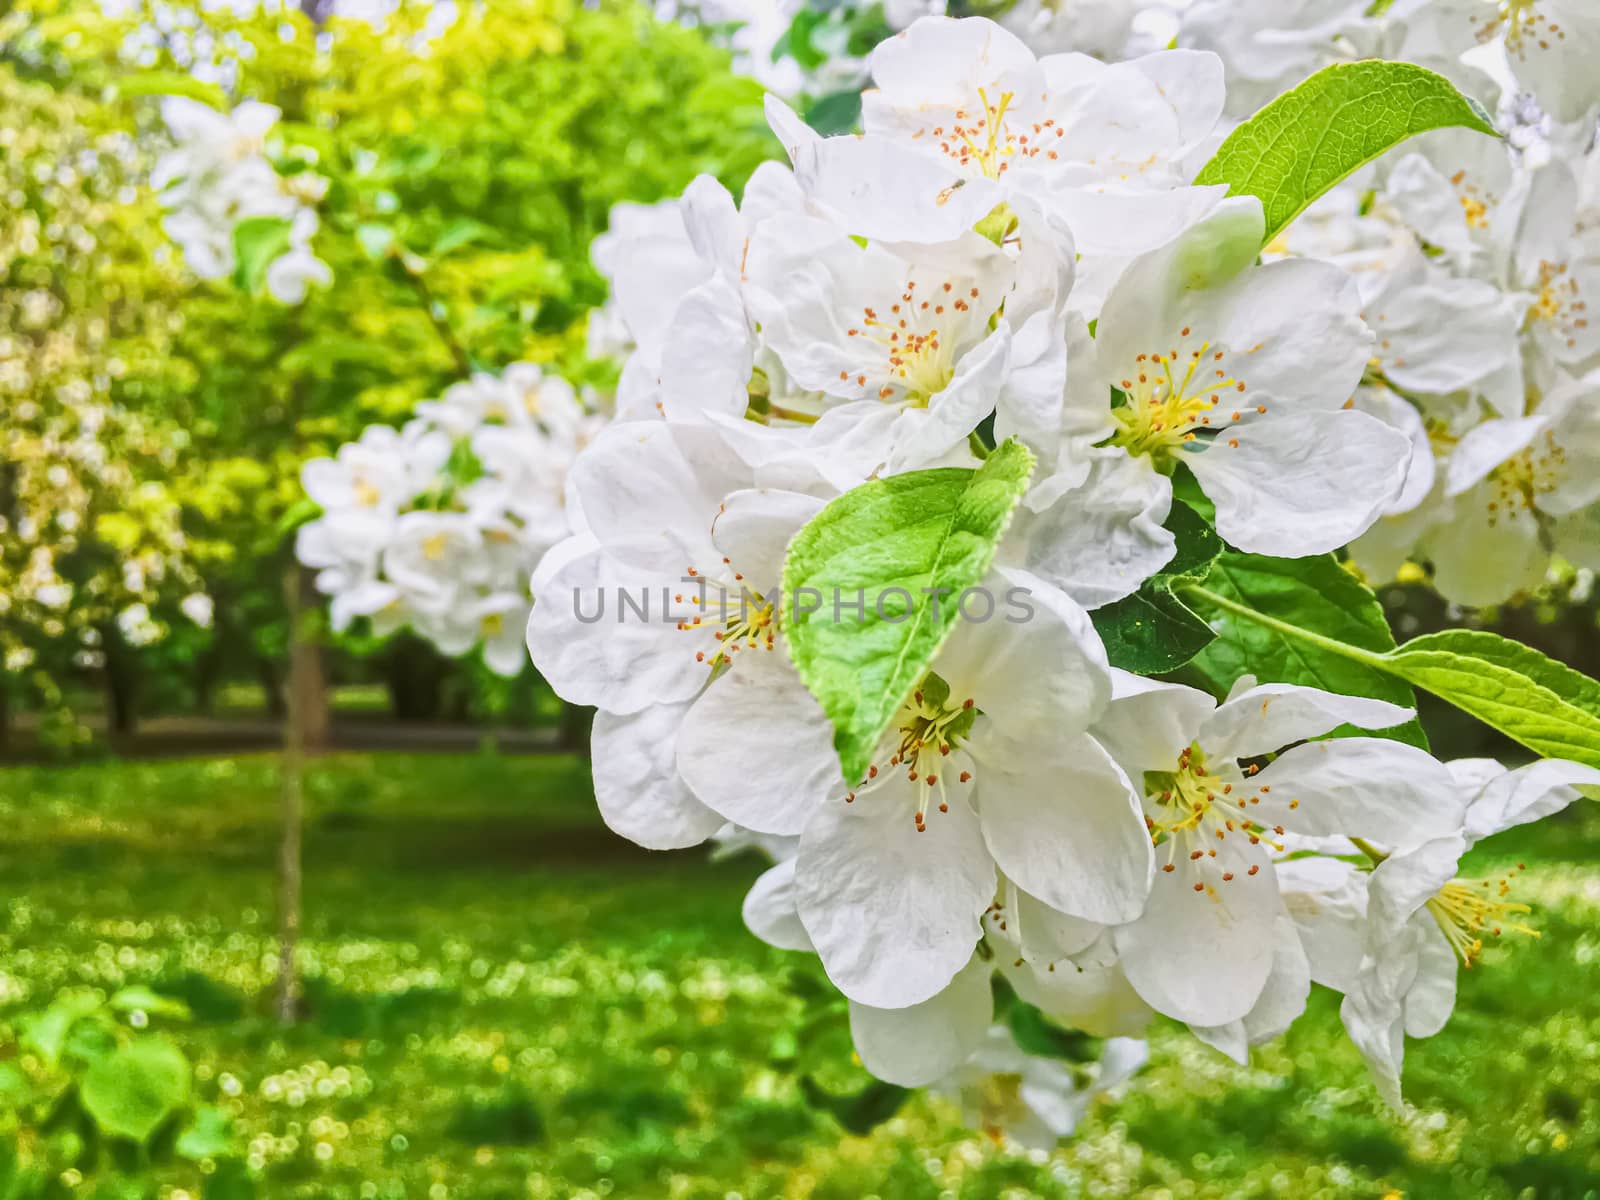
[795,784,995,1008]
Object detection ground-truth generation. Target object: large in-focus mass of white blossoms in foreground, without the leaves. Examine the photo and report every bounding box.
[528,14,1600,1115]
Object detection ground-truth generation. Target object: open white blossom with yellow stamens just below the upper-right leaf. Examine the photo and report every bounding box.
[1036,198,1411,557]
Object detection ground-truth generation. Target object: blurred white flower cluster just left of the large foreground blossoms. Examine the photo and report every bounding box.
[296,363,600,675]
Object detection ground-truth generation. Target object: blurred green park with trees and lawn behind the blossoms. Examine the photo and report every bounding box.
[0,0,1600,1200]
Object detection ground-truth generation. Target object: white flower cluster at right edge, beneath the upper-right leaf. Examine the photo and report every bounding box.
[1241,25,1600,606]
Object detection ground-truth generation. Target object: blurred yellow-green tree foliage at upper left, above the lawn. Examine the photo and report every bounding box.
[0,0,778,752]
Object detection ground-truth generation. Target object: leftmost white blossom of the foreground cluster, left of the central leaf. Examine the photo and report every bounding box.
[526,421,837,850]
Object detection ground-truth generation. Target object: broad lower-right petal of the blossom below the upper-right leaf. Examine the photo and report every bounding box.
[1184,410,1411,558]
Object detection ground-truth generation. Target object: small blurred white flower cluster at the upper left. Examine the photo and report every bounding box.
[150,96,333,304]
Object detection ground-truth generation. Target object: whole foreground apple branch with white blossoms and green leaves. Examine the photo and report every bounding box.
[526,16,1600,1142]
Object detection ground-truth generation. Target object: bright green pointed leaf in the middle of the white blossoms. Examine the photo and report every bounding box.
[782,438,1034,782]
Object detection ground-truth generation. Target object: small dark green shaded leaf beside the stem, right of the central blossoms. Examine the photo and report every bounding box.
[1090,501,1222,675]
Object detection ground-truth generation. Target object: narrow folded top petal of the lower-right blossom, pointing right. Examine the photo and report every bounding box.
[1197,683,1416,758]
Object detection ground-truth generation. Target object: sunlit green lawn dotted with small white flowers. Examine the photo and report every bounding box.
[0,755,1600,1200]
